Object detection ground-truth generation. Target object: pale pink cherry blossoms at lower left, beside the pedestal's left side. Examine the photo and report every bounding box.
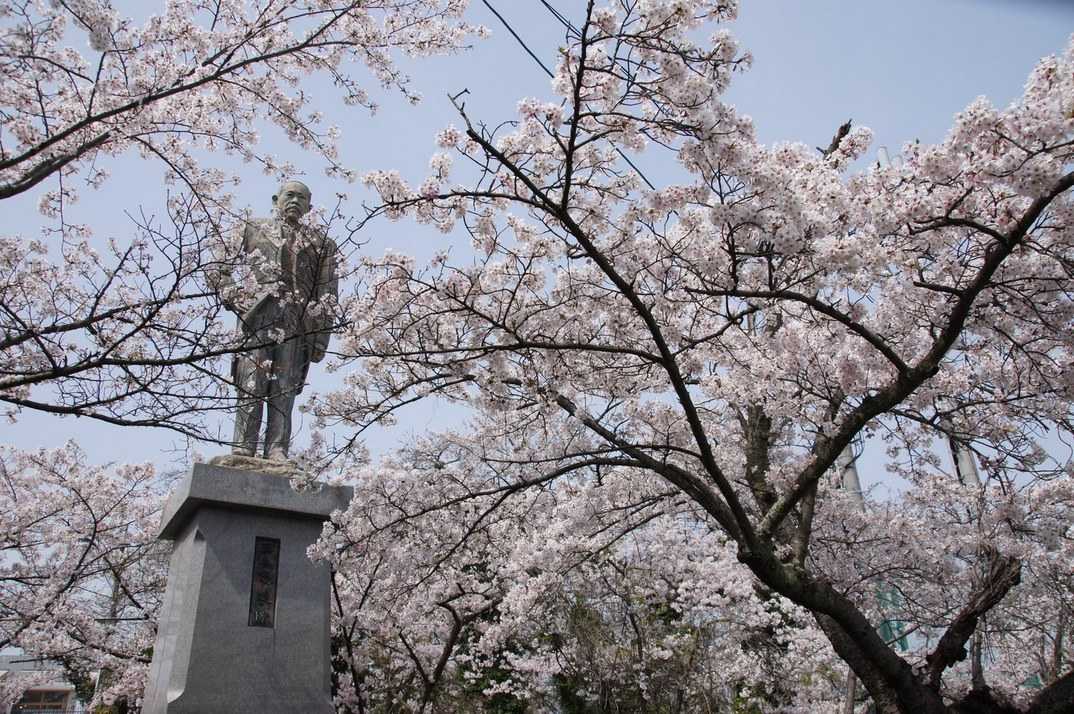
[0,442,170,706]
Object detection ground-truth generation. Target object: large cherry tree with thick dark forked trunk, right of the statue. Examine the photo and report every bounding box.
[326,0,1074,714]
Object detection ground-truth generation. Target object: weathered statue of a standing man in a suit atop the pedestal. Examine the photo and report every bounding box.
[218,180,338,461]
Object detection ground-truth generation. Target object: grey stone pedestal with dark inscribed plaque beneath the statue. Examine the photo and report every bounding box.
[142,464,350,714]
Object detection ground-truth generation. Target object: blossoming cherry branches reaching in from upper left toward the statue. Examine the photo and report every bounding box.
[0,0,471,436]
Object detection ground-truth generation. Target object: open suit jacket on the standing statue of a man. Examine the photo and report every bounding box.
[236,218,339,390]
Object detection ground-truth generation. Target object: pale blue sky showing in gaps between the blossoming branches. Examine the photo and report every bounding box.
[8,0,1074,486]
